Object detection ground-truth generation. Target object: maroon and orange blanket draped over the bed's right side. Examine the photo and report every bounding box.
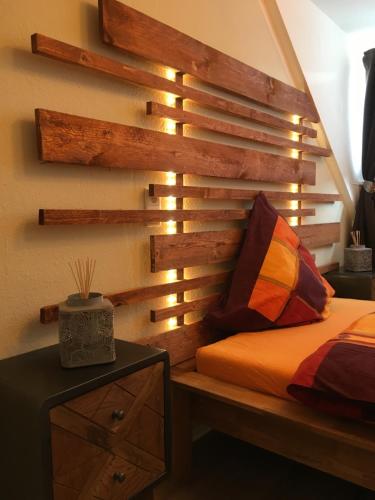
[287,314,375,421]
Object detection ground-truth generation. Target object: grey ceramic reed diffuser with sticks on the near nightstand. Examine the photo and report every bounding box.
[59,259,116,368]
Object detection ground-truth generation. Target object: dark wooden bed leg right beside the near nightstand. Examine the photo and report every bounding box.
[172,385,192,483]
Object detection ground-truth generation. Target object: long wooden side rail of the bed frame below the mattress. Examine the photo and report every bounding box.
[194,391,375,492]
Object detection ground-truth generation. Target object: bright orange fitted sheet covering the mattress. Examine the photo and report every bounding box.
[196,298,375,399]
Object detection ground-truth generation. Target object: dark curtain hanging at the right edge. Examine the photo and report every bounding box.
[353,49,375,267]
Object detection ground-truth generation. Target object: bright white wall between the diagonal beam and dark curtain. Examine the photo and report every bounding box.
[276,0,361,200]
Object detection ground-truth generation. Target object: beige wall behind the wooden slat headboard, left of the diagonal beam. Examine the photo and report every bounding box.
[0,0,340,357]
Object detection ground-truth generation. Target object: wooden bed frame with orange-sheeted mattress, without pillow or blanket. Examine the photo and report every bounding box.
[172,299,375,490]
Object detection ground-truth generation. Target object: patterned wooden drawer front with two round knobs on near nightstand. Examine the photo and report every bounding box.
[50,362,165,500]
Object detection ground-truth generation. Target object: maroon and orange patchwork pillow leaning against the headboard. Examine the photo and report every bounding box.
[206,193,333,333]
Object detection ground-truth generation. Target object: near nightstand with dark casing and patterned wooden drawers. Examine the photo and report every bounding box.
[0,340,170,500]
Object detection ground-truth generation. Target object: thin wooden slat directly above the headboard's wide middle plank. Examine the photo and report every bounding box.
[146,101,331,157]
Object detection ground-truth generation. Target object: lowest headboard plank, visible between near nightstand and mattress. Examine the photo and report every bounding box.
[137,321,220,366]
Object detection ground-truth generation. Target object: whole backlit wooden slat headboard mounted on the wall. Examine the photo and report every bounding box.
[32,0,341,364]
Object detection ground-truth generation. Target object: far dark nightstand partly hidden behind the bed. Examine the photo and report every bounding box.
[324,269,375,300]
